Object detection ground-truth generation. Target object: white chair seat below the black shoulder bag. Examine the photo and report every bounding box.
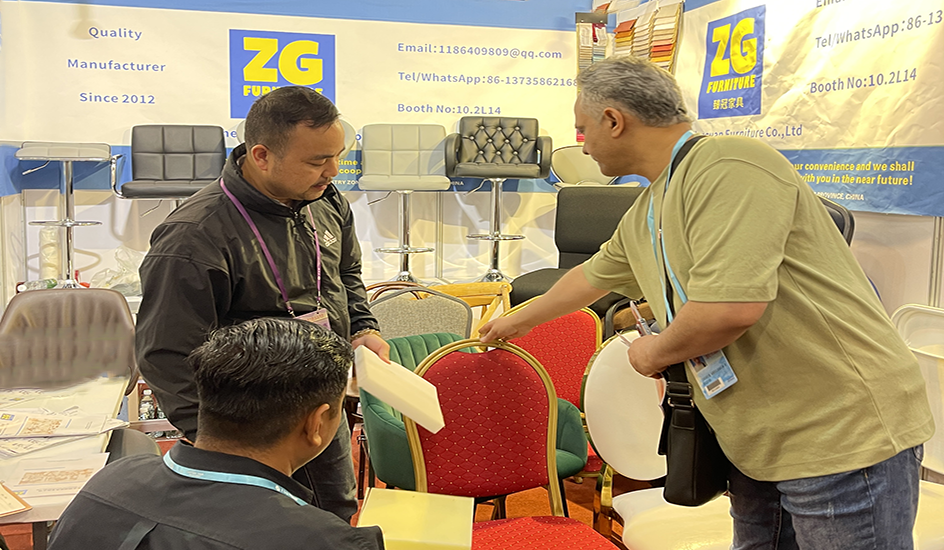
[613,488,734,550]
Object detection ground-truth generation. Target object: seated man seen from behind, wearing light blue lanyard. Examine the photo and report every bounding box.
[50,318,383,550]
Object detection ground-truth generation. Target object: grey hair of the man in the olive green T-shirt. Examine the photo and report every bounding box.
[577,56,692,128]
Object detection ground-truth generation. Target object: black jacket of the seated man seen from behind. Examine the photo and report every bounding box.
[49,443,384,550]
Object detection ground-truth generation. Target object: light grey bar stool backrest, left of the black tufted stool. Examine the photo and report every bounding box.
[358,124,450,190]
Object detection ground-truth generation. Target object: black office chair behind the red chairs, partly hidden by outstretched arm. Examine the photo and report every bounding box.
[510,185,644,330]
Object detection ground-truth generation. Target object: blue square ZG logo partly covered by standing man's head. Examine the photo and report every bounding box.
[229,29,335,118]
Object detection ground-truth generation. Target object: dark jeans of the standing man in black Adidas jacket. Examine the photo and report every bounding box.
[292,411,357,523]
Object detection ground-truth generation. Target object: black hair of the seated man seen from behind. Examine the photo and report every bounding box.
[189,318,354,449]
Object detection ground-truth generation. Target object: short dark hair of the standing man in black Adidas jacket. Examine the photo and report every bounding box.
[246,86,341,154]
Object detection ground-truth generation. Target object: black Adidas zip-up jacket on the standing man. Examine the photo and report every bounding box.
[135,145,378,440]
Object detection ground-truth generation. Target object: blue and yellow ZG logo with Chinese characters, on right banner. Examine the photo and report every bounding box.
[698,6,766,118]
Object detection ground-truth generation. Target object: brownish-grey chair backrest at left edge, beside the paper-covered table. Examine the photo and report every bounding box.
[0,288,137,388]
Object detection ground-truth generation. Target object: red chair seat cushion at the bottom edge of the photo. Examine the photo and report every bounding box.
[472,516,616,550]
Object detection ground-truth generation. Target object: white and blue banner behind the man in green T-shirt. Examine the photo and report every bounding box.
[676,0,944,216]
